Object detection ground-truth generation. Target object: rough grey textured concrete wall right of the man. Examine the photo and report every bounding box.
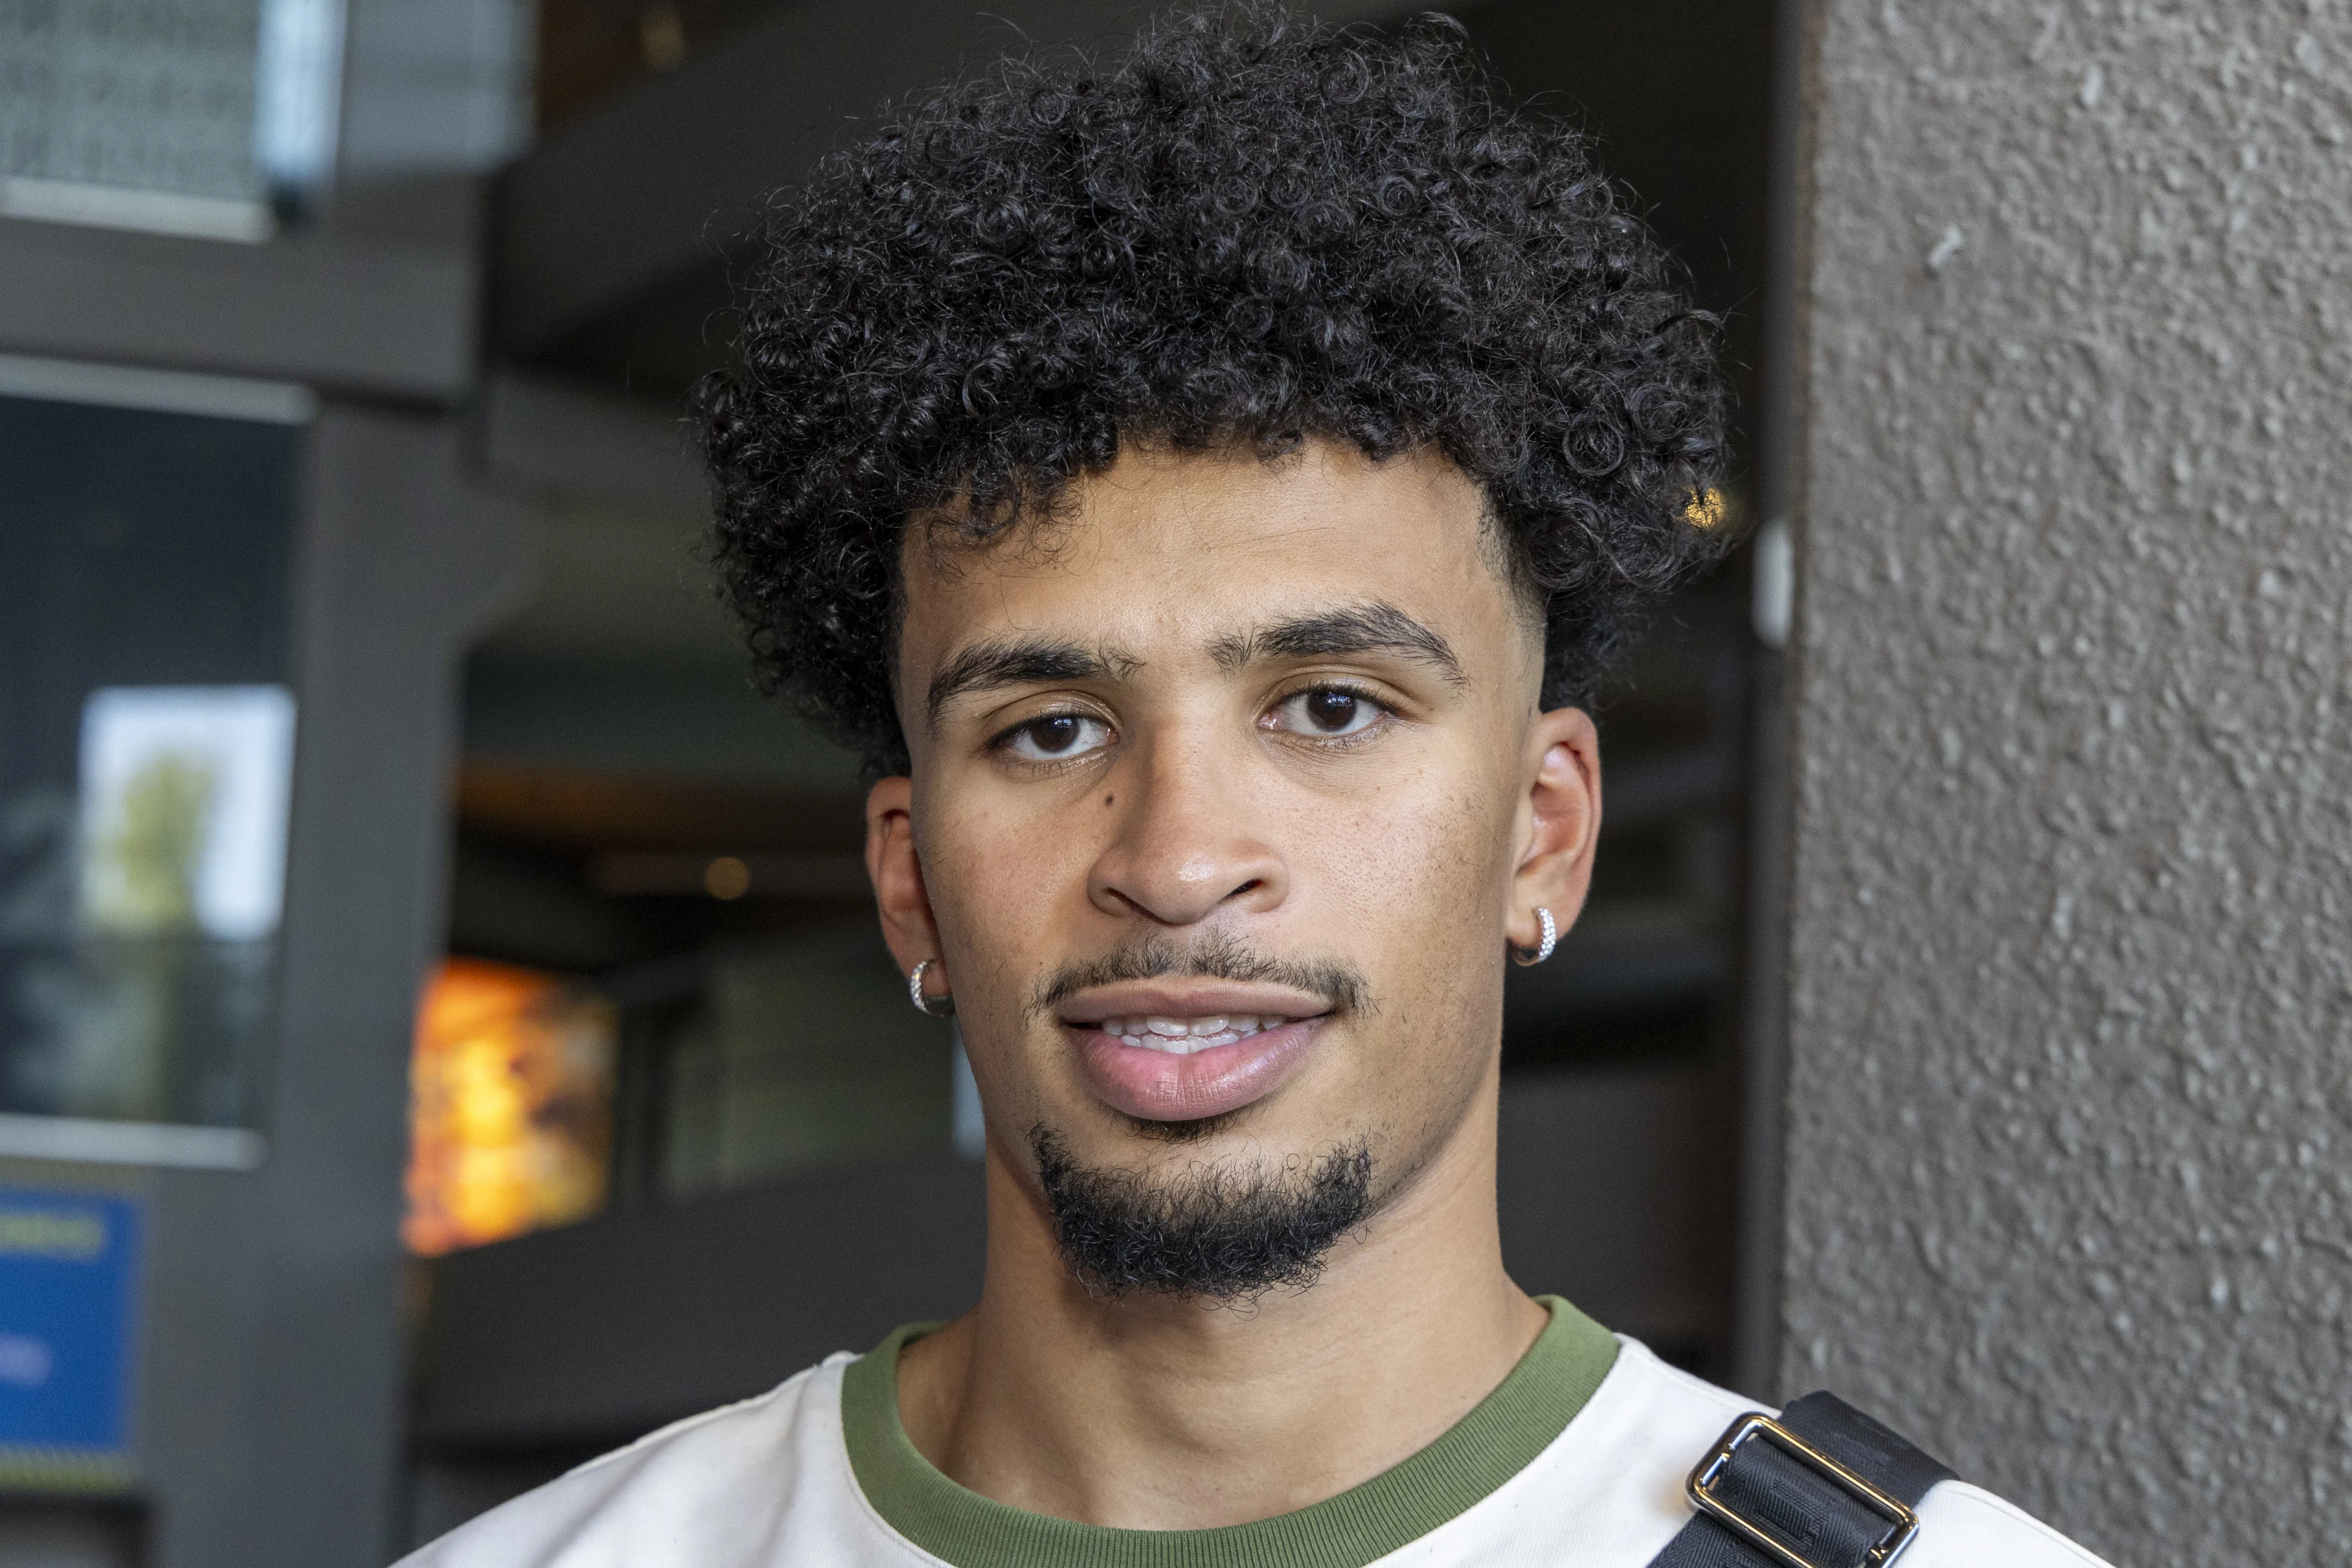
[1783,0,2352,1568]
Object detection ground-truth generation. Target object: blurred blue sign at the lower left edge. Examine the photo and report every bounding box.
[0,1187,141,1462]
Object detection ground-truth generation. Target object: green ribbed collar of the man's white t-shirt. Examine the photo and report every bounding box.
[842,1295,1618,1568]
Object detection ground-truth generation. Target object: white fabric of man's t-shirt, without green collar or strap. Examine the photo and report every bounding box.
[398,1305,2105,1568]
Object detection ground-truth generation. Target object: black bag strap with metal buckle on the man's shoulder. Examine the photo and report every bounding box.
[1651,1394,1952,1568]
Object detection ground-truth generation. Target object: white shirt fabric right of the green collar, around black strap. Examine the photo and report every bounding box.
[1472,1338,2105,1568]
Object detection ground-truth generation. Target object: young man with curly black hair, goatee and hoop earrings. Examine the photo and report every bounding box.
[412,9,2095,1568]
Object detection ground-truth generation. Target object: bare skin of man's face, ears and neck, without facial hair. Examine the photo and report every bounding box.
[865,444,1599,1528]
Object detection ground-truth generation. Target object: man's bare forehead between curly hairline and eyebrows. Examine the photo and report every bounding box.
[901,442,1540,689]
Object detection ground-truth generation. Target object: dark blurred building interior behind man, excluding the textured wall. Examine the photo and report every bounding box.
[0,0,1790,1568]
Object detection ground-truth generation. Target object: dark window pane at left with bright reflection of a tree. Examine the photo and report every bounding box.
[0,398,301,1164]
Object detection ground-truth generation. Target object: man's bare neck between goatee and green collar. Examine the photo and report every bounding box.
[899,1069,1545,1531]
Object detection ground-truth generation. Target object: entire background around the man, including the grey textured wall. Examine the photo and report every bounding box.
[18,0,2352,1568]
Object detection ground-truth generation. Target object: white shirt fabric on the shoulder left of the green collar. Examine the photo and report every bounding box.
[398,1354,884,1568]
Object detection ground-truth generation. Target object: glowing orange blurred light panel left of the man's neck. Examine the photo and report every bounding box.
[400,959,616,1256]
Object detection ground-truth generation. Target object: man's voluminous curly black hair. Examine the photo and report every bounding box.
[696,0,1727,771]
